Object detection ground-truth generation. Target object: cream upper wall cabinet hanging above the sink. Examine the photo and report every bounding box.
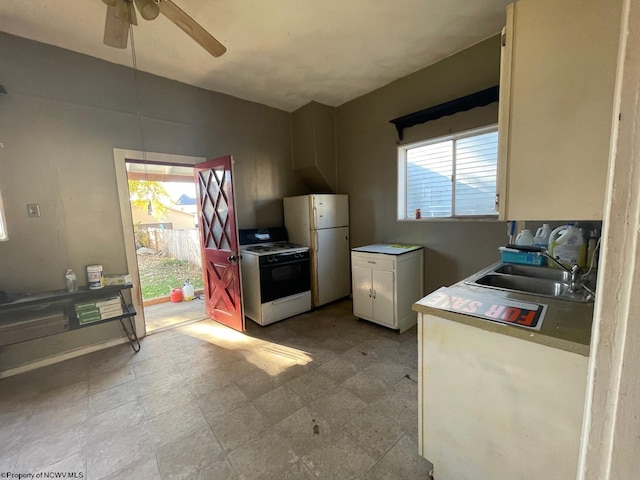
[498,0,622,220]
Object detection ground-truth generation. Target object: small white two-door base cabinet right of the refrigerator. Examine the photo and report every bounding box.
[351,246,424,333]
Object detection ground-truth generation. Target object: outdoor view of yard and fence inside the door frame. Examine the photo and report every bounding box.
[125,160,205,333]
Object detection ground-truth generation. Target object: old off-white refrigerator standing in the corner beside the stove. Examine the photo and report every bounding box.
[284,194,351,307]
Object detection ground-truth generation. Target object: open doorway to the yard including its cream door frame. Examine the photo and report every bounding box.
[114,149,206,334]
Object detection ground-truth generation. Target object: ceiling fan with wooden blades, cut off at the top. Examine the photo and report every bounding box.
[102,0,227,57]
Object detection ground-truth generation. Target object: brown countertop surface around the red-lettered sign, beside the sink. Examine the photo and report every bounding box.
[413,270,593,357]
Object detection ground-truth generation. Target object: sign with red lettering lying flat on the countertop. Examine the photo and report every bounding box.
[420,287,547,330]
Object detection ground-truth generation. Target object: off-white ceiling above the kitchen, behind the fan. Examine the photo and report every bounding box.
[0,0,510,112]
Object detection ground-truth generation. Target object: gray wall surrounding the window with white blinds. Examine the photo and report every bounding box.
[337,36,507,293]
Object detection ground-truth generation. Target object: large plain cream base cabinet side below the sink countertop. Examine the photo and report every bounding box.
[418,313,589,480]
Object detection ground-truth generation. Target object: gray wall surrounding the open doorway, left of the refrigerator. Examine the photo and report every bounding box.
[0,33,305,371]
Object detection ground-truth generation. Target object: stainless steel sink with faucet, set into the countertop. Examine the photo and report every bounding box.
[465,262,595,303]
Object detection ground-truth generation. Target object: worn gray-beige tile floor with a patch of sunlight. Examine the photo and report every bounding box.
[0,301,429,480]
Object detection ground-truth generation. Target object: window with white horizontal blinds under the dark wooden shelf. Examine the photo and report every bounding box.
[398,125,498,220]
